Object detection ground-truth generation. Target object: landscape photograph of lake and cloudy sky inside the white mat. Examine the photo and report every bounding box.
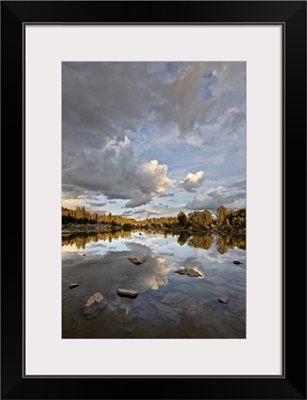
[59,61,248,339]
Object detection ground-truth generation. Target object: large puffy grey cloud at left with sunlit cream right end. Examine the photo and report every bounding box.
[62,136,174,207]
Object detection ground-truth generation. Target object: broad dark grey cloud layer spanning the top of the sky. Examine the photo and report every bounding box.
[62,62,246,159]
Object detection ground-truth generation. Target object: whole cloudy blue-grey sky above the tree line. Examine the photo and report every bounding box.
[62,62,246,219]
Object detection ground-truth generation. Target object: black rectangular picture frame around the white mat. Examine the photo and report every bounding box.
[1,1,306,399]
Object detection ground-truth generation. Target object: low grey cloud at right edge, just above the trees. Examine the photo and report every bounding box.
[186,181,246,212]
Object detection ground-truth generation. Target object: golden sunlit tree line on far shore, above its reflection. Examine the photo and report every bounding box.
[62,206,246,231]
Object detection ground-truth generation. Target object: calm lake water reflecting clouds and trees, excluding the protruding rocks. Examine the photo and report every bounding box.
[62,230,246,339]
